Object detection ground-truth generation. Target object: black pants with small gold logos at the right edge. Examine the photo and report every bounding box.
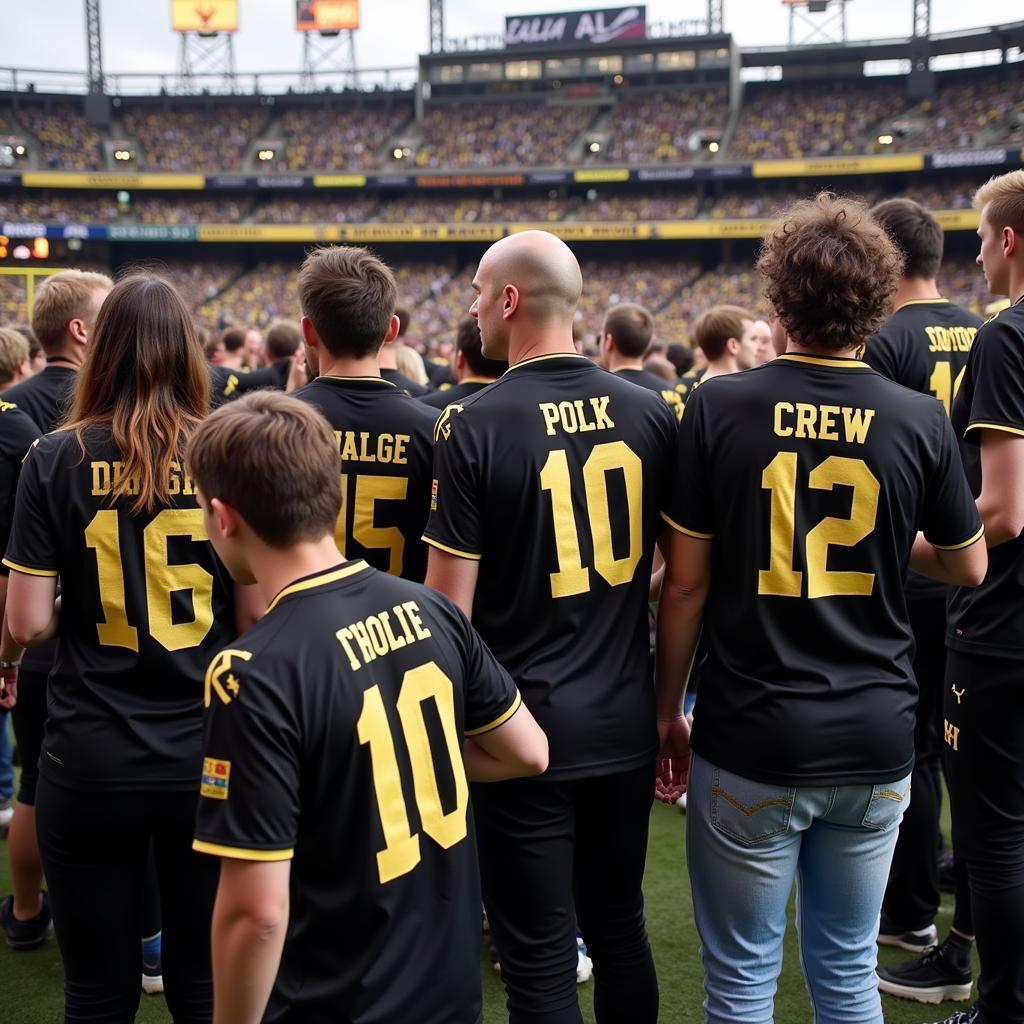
[943,650,1024,1024]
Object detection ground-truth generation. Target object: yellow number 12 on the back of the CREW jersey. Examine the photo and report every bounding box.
[758,452,880,598]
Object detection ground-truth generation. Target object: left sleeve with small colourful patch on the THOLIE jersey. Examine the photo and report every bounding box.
[193,650,301,861]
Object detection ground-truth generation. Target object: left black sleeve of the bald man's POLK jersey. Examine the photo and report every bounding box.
[423,404,483,560]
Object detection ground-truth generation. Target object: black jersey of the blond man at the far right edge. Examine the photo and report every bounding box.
[947,302,1024,657]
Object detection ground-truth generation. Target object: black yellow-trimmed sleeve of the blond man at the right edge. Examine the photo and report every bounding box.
[964,317,1024,444]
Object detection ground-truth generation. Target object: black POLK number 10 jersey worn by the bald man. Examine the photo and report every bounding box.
[425,355,676,778]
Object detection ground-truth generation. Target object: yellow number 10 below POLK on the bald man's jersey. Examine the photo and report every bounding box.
[541,441,643,597]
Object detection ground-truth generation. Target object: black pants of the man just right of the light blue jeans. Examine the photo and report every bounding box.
[882,595,946,930]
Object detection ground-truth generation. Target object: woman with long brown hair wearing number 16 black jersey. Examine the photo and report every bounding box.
[4,274,237,1024]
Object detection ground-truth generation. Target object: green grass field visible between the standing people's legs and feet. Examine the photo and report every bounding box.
[0,805,977,1024]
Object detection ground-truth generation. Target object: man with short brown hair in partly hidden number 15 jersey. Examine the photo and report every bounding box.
[295,237,436,582]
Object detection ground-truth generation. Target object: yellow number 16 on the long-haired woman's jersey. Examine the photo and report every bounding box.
[85,509,213,651]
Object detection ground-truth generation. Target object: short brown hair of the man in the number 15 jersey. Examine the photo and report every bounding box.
[298,246,398,358]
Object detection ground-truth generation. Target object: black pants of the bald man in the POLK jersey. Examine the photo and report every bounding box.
[473,764,657,1024]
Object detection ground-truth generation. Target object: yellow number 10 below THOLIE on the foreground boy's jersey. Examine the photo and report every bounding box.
[356,662,469,885]
